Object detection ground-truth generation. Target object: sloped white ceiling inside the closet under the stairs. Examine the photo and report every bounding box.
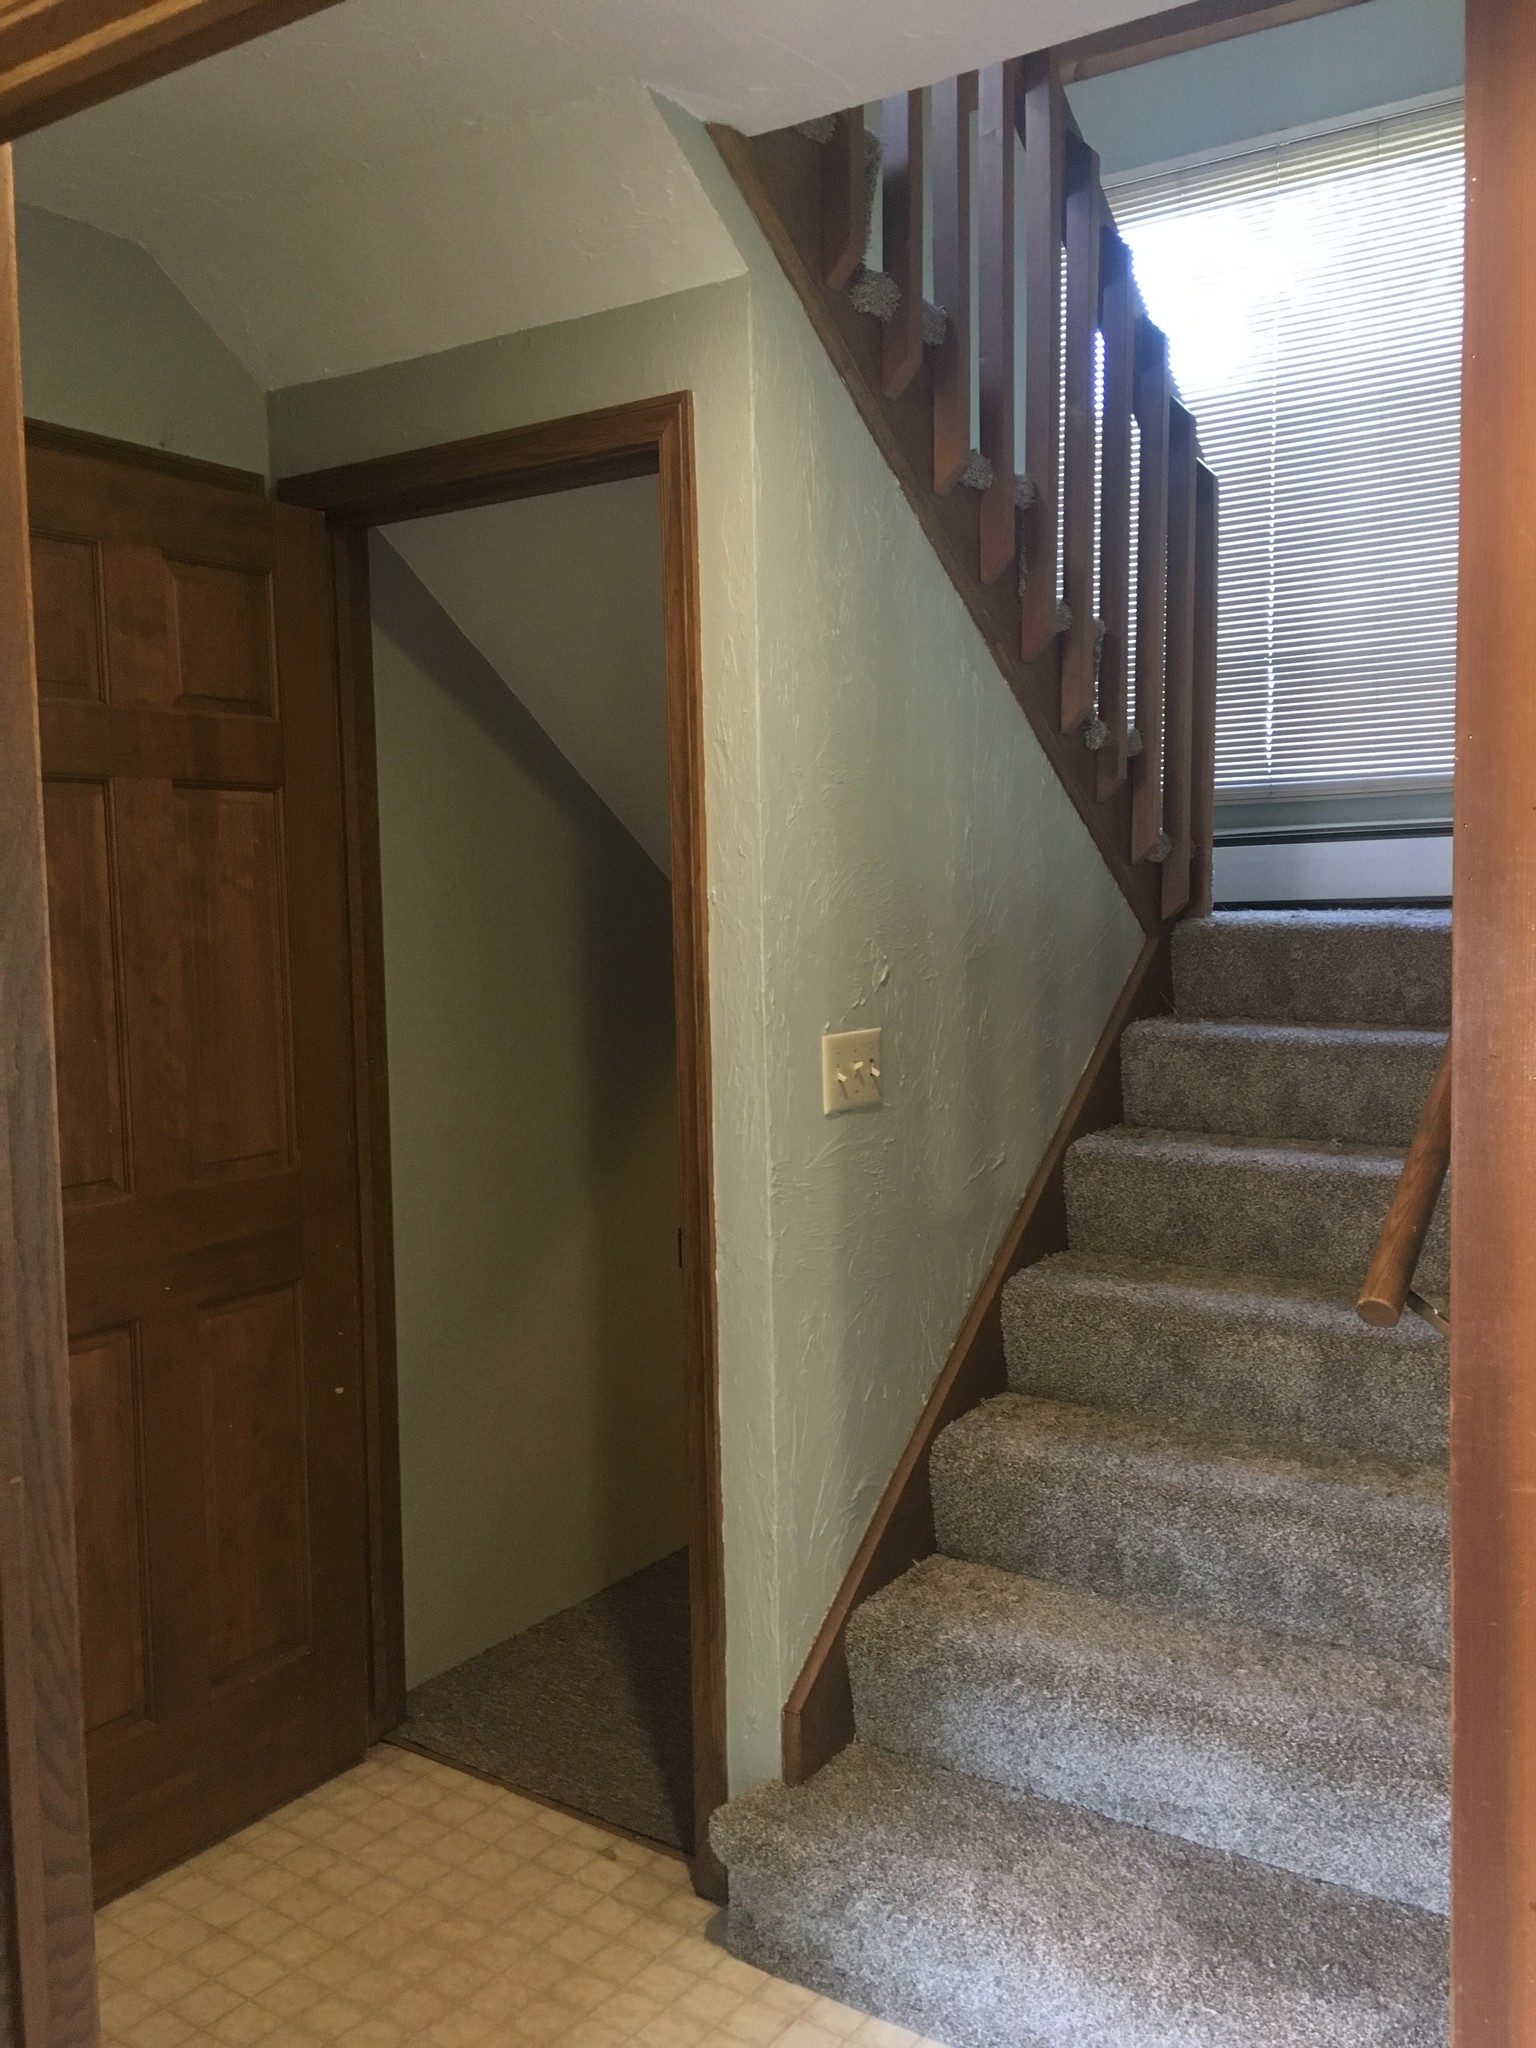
[383,477,672,872]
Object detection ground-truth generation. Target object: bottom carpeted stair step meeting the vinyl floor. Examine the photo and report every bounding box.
[713,1743,1448,2048]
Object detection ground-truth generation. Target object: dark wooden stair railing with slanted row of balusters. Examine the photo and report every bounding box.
[715,51,1219,922]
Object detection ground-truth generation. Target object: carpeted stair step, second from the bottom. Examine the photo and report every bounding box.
[848,1556,1450,1913]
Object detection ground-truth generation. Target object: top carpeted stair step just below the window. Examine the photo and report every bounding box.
[1174,909,1450,1030]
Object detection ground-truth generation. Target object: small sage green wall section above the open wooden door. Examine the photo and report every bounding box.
[16,207,266,475]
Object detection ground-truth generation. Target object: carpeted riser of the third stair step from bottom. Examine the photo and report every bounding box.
[932,1430,1450,1665]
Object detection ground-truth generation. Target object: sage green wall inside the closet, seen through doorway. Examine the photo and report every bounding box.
[373,541,686,1683]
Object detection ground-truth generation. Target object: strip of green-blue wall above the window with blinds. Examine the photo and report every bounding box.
[1067,0,1464,176]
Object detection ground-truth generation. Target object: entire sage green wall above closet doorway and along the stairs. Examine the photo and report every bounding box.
[270,109,1139,1788]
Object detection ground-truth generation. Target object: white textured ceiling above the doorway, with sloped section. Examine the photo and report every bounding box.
[16,0,1149,389]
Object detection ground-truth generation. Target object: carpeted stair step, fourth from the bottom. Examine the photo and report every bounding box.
[1001,1251,1450,1462]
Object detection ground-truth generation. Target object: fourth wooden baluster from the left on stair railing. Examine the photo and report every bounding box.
[977,59,1020,584]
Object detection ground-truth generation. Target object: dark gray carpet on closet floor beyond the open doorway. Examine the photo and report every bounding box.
[395,1550,692,1853]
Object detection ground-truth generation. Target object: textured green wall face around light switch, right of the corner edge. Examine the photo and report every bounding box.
[678,121,1141,1728]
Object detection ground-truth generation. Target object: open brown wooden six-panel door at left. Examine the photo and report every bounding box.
[29,432,367,1898]
